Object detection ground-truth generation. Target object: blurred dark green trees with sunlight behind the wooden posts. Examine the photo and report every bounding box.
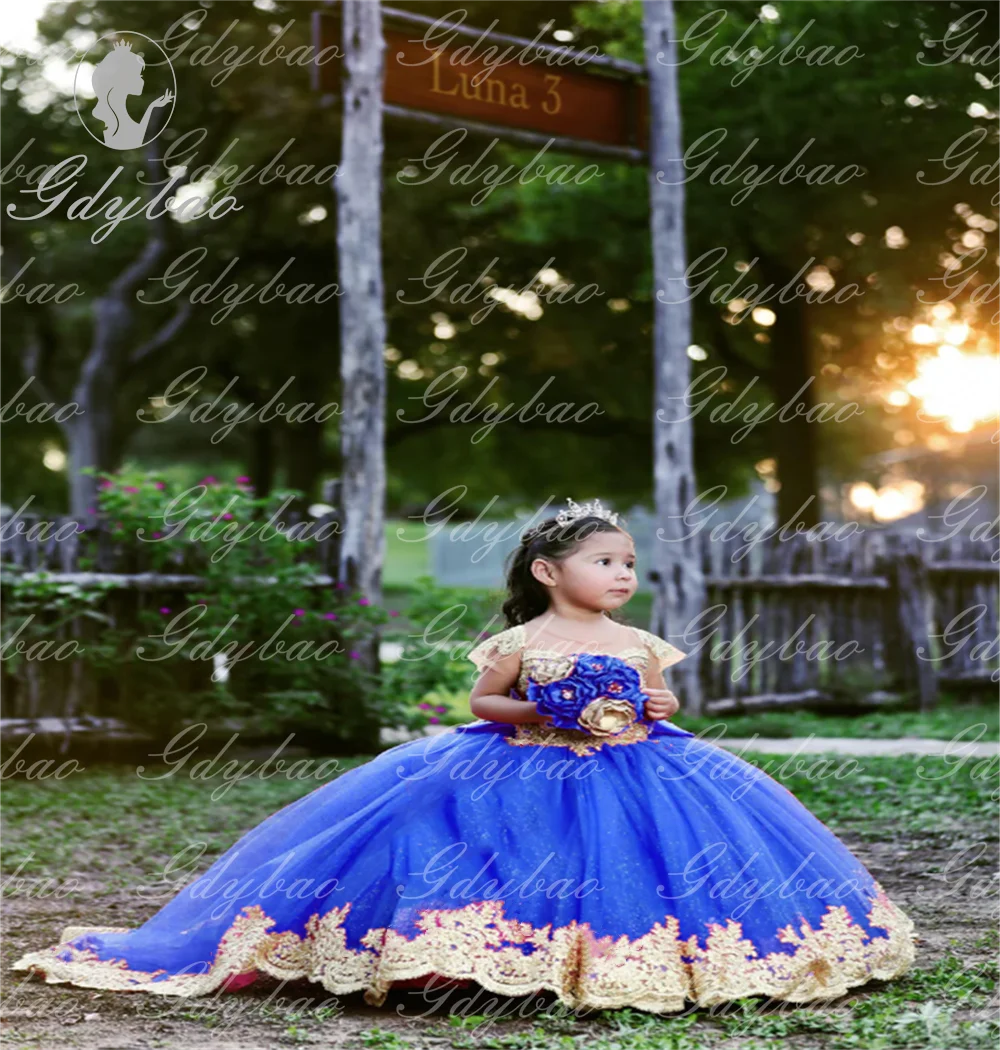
[0,0,1000,521]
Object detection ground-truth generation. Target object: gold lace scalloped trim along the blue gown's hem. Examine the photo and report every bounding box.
[12,883,916,1013]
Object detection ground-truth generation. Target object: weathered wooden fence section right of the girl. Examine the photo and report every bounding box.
[693,530,1000,714]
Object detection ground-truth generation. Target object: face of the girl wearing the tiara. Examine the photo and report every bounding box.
[532,529,639,611]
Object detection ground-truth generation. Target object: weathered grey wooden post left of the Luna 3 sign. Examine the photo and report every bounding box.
[335,0,386,747]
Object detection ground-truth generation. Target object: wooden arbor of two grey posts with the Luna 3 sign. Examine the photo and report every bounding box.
[313,0,704,713]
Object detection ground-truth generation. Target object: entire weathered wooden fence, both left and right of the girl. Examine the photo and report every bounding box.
[0,493,1000,719]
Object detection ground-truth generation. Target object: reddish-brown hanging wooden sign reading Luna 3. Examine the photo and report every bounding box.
[313,12,648,151]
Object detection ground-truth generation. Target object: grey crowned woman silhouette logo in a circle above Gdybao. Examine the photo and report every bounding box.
[74,33,176,149]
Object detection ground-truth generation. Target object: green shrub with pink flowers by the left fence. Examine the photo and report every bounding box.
[5,470,397,750]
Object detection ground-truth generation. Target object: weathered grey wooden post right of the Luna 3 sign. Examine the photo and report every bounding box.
[643,0,705,715]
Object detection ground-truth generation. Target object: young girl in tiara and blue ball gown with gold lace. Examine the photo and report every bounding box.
[9,501,915,1013]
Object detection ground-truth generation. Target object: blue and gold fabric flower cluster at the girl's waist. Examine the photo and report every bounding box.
[527,653,646,736]
